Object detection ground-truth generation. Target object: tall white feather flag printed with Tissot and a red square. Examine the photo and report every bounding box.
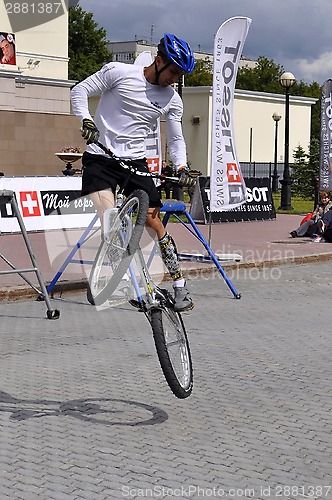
[210,17,251,212]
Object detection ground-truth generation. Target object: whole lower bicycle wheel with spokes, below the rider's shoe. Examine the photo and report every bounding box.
[148,306,193,399]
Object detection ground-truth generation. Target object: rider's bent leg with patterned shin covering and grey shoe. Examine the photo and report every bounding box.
[146,208,194,311]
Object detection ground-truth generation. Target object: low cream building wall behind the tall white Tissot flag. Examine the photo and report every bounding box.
[183,87,316,175]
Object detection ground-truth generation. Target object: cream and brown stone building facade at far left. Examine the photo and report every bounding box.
[0,1,84,176]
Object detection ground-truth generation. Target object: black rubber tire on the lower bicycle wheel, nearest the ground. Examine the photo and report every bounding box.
[149,305,193,399]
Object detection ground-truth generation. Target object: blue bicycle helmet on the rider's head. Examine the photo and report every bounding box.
[158,33,195,73]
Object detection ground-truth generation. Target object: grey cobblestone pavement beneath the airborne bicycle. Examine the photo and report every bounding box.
[0,262,332,500]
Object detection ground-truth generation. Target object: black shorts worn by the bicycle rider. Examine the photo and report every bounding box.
[82,152,163,208]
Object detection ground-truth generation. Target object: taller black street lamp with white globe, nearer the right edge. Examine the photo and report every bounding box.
[279,71,296,210]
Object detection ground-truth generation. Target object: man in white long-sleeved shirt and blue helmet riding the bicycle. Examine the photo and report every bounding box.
[71,33,195,312]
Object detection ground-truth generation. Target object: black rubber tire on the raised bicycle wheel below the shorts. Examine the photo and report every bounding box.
[87,189,149,306]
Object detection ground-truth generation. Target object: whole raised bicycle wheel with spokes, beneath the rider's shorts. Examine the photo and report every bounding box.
[87,190,149,305]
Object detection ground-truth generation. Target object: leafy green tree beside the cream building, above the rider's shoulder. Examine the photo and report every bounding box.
[68,6,111,81]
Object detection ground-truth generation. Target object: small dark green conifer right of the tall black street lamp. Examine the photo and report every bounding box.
[292,138,320,200]
